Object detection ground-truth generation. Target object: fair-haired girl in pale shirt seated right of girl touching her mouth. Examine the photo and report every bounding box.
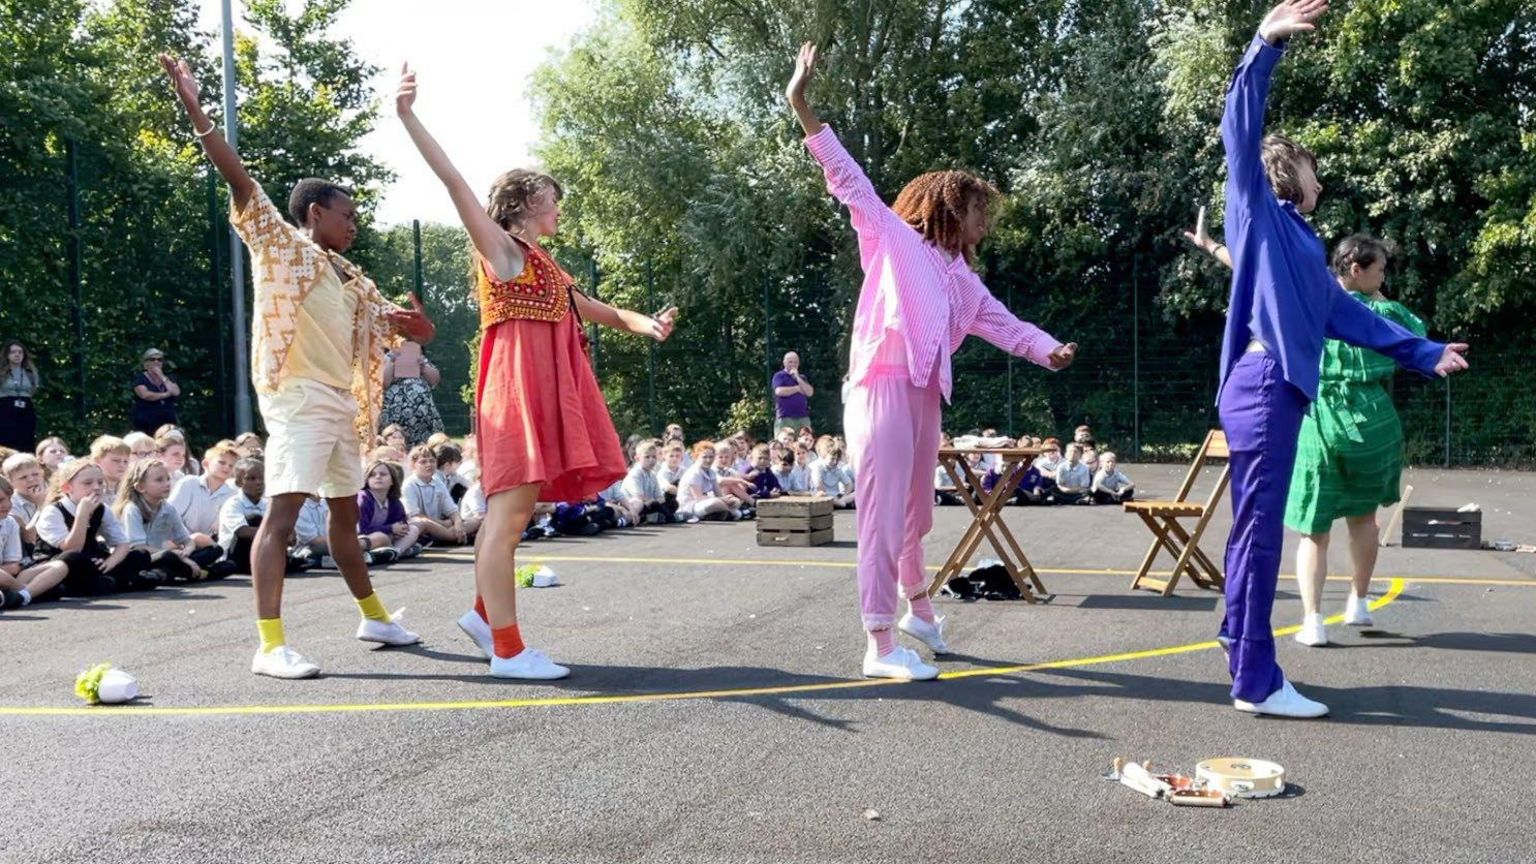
[112,457,225,581]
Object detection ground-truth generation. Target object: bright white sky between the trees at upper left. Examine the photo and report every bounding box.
[201,0,596,224]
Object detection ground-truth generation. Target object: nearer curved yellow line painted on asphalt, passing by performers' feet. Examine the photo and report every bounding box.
[0,580,1404,716]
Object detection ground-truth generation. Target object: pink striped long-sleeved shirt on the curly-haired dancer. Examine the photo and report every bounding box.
[805,126,1061,401]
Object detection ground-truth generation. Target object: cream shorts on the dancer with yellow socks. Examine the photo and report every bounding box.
[257,378,362,498]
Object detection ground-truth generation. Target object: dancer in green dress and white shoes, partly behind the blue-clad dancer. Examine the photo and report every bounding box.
[1184,208,1424,646]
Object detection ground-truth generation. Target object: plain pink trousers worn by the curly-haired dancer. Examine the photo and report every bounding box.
[843,366,942,630]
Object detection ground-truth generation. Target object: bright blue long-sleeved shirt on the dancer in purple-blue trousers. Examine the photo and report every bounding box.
[1218,35,1445,400]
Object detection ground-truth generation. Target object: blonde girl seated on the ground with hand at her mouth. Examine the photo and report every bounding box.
[34,460,169,596]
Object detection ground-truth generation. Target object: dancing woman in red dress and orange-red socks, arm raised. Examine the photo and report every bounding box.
[395,68,677,680]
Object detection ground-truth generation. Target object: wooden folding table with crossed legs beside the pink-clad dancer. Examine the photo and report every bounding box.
[928,447,1046,603]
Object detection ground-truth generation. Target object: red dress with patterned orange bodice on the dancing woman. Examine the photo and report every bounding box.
[475,241,628,501]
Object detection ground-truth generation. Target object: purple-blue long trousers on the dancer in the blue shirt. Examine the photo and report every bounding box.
[1220,352,1307,703]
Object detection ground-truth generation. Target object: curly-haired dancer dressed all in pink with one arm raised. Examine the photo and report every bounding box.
[786,43,1077,681]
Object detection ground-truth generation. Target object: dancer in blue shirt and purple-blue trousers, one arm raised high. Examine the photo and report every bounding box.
[1218,0,1467,716]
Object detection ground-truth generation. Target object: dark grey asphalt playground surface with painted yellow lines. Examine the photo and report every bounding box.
[0,466,1536,864]
